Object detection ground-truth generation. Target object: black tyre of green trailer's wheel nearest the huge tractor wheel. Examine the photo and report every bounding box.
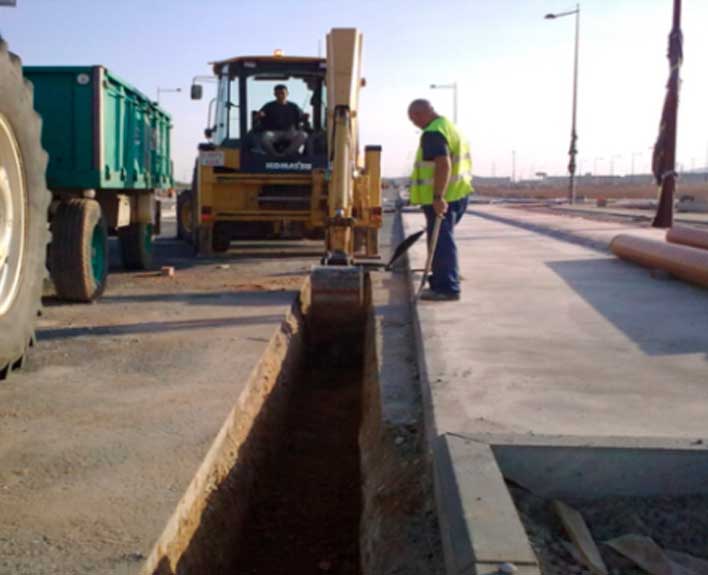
[49,199,108,302]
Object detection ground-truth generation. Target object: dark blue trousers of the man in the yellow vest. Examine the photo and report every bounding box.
[423,197,468,293]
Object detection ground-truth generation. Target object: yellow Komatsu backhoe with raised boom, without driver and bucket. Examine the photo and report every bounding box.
[187,29,381,265]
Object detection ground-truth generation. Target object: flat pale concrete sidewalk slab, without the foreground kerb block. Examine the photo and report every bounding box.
[404,208,708,437]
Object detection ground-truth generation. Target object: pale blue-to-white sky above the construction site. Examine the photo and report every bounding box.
[0,0,708,180]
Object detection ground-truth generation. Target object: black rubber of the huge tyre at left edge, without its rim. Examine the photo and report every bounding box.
[0,38,51,379]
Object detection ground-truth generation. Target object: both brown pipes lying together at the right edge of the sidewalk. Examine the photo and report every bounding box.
[610,226,708,287]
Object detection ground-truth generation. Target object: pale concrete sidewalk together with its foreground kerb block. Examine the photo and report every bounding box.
[403,207,708,575]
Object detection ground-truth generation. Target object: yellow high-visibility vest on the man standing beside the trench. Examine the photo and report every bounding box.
[410,116,474,205]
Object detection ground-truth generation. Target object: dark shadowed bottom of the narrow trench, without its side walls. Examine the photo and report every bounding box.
[232,322,364,575]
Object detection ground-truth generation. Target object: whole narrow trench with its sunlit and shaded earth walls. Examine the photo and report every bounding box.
[147,268,443,575]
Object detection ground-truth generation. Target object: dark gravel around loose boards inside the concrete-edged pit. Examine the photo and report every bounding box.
[510,487,708,575]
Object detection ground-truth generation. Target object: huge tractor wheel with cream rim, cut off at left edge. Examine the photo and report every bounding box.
[0,38,51,379]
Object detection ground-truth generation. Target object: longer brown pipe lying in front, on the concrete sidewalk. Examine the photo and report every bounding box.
[610,234,708,287]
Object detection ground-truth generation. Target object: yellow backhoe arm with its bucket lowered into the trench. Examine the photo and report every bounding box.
[311,28,381,336]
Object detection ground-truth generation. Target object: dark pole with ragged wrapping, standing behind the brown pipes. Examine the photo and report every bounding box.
[652,0,683,228]
